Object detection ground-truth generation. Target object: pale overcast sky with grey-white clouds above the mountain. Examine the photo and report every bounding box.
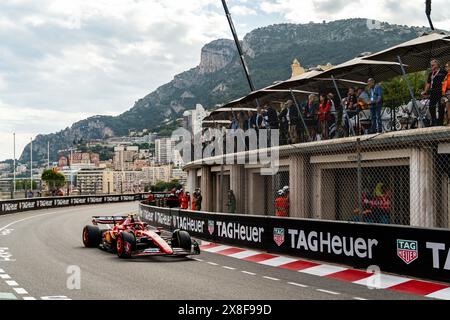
[0,0,450,160]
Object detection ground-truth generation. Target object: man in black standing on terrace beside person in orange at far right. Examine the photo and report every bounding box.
[422,60,446,126]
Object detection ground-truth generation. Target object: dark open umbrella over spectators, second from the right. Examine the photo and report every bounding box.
[320,58,408,82]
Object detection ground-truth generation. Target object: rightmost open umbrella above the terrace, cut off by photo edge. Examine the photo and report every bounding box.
[363,33,450,72]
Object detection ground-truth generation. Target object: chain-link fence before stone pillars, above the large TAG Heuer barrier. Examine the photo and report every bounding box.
[220,127,450,228]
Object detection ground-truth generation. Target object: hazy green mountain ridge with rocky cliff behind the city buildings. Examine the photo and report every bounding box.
[20,19,429,162]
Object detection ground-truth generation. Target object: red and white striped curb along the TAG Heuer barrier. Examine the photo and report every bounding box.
[200,241,450,300]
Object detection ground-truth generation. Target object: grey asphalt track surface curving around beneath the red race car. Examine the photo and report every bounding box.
[0,203,424,300]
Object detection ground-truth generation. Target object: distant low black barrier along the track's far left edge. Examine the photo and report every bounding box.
[0,194,146,215]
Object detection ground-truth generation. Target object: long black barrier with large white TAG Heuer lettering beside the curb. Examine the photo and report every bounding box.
[140,204,450,282]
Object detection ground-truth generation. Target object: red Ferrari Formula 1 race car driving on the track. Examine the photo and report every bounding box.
[83,215,200,259]
